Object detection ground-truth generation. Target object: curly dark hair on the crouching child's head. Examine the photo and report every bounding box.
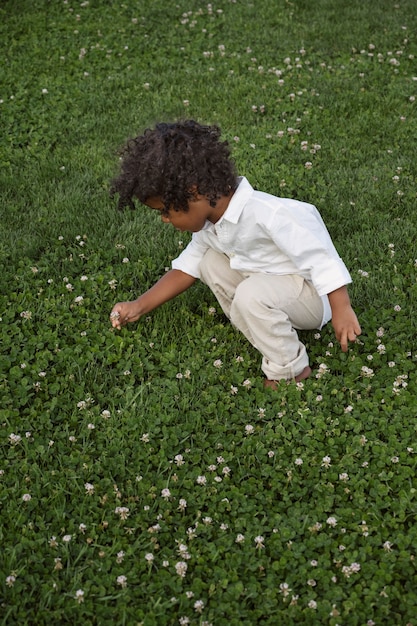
[110,120,237,212]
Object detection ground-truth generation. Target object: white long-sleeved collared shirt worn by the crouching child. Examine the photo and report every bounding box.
[172,177,352,324]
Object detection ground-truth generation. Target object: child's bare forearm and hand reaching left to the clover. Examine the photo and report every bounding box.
[110,270,196,330]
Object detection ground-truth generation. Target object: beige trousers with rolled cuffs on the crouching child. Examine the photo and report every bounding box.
[200,249,323,380]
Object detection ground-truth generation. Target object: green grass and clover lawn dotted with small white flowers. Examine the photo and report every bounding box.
[0,0,417,626]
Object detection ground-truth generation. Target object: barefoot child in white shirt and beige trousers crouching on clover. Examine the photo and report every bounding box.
[110,120,361,388]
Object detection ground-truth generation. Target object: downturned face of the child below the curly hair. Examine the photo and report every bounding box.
[144,196,222,233]
